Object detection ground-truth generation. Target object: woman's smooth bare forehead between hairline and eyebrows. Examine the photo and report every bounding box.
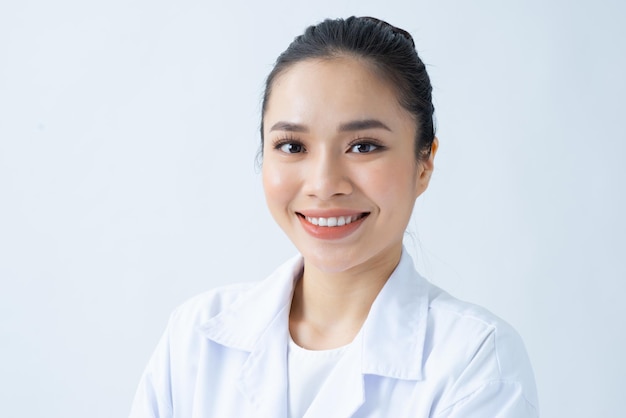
[264,57,412,131]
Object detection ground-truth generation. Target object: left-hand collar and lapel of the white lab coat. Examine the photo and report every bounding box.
[201,256,302,418]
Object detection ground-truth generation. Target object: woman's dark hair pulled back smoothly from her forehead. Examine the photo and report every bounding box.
[261,16,435,161]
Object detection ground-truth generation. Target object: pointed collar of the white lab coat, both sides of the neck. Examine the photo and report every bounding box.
[201,248,429,380]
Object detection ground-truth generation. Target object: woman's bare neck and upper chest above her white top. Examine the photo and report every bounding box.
[289,248,402,350]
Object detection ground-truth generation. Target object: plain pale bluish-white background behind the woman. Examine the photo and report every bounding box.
[0,0,626,418]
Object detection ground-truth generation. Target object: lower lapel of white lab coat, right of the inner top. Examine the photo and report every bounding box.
[304,334,365,418]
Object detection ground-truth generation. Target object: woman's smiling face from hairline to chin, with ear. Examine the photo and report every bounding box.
[263,58,434,273]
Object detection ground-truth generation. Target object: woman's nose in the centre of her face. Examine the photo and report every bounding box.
[304,152,353,200]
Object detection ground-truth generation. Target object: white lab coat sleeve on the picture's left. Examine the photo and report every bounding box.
[129,325,173,418]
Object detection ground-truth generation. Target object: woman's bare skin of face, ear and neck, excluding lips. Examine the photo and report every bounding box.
[262,57,438,349]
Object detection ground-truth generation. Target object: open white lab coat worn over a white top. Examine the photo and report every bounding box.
[130,251,538,418]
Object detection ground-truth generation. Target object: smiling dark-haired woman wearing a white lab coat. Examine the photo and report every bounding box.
[131,17,538,418]
